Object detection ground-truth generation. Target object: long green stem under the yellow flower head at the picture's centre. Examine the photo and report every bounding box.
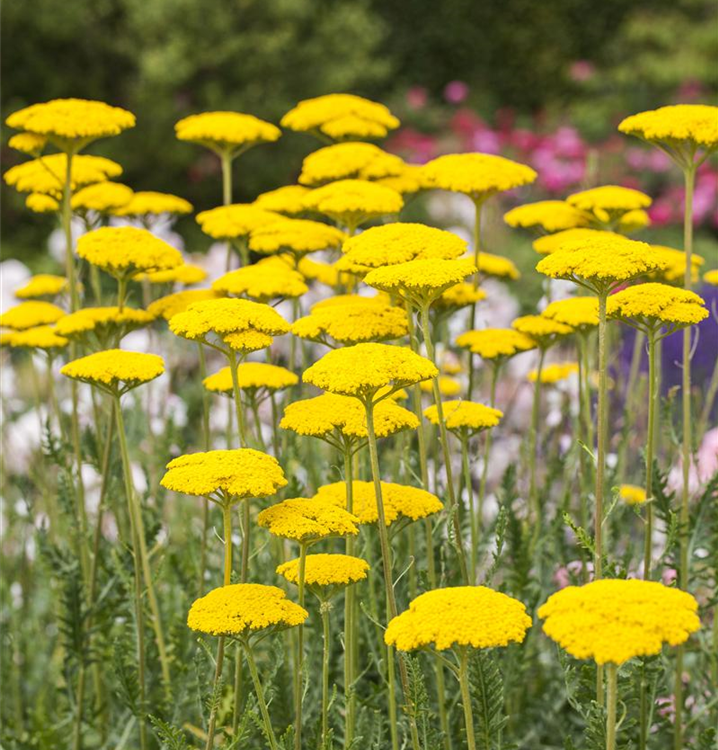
[364,397,420,750]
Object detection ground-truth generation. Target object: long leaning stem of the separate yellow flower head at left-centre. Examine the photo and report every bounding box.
[115,394,171,698]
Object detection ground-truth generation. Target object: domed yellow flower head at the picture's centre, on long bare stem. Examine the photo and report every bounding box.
[303,344,439,399]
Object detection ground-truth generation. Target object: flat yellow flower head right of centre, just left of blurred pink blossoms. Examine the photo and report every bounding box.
[421,154,536,201]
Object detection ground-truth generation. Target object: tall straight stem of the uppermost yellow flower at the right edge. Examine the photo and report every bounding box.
[673,162,696,750]
